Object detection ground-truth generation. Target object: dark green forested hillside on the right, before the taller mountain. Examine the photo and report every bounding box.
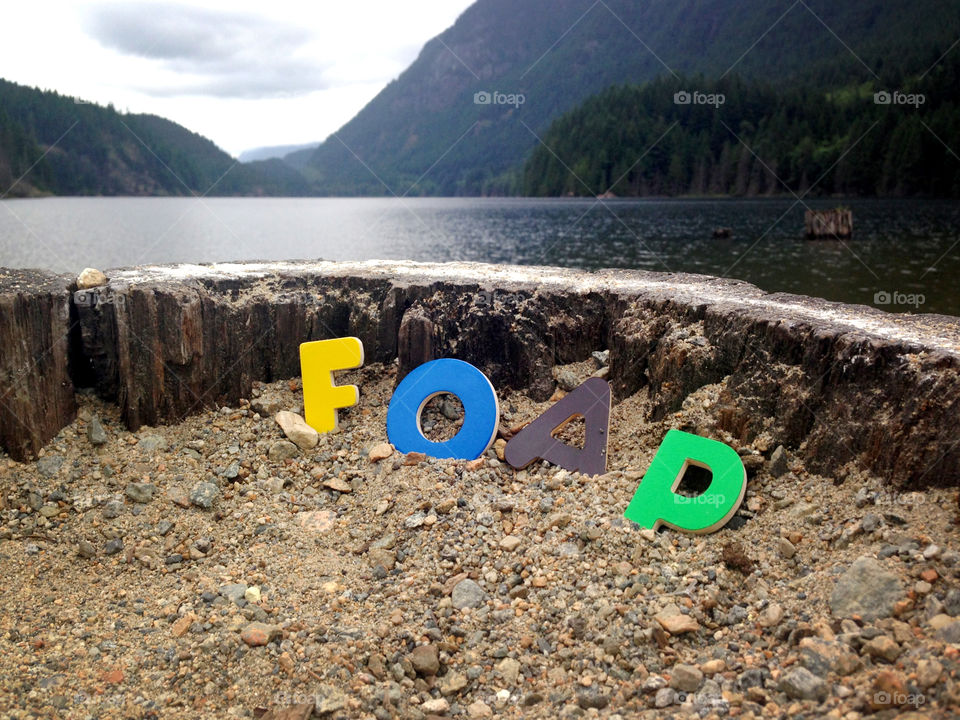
[522,58,960,197]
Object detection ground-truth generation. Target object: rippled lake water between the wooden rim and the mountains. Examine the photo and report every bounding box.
[0,198,960,315]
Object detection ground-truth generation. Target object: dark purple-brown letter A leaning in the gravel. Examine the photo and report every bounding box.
[503,378,610,475]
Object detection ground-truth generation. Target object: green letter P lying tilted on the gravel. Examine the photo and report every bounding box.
[624,430,747,534]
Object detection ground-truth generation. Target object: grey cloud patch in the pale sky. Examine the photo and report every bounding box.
[84,2,330,99]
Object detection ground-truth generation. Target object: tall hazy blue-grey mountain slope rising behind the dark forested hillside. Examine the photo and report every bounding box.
[296,0,960,195]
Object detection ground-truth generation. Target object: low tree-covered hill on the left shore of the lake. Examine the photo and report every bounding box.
[0,80,310,197]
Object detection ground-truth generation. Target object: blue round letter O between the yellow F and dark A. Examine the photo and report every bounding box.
[387,358,500,460]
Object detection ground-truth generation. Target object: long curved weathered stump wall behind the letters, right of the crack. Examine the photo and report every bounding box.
[1,262,960,486]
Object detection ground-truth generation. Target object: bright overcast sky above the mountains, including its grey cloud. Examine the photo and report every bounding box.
[0,0,473,156]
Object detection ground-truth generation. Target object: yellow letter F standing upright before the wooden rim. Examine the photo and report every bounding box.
[300,338,363,432]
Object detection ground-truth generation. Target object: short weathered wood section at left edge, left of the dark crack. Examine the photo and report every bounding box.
[0,269,77,460]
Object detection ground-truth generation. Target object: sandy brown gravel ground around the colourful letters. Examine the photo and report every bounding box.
[0,358,960,720]
